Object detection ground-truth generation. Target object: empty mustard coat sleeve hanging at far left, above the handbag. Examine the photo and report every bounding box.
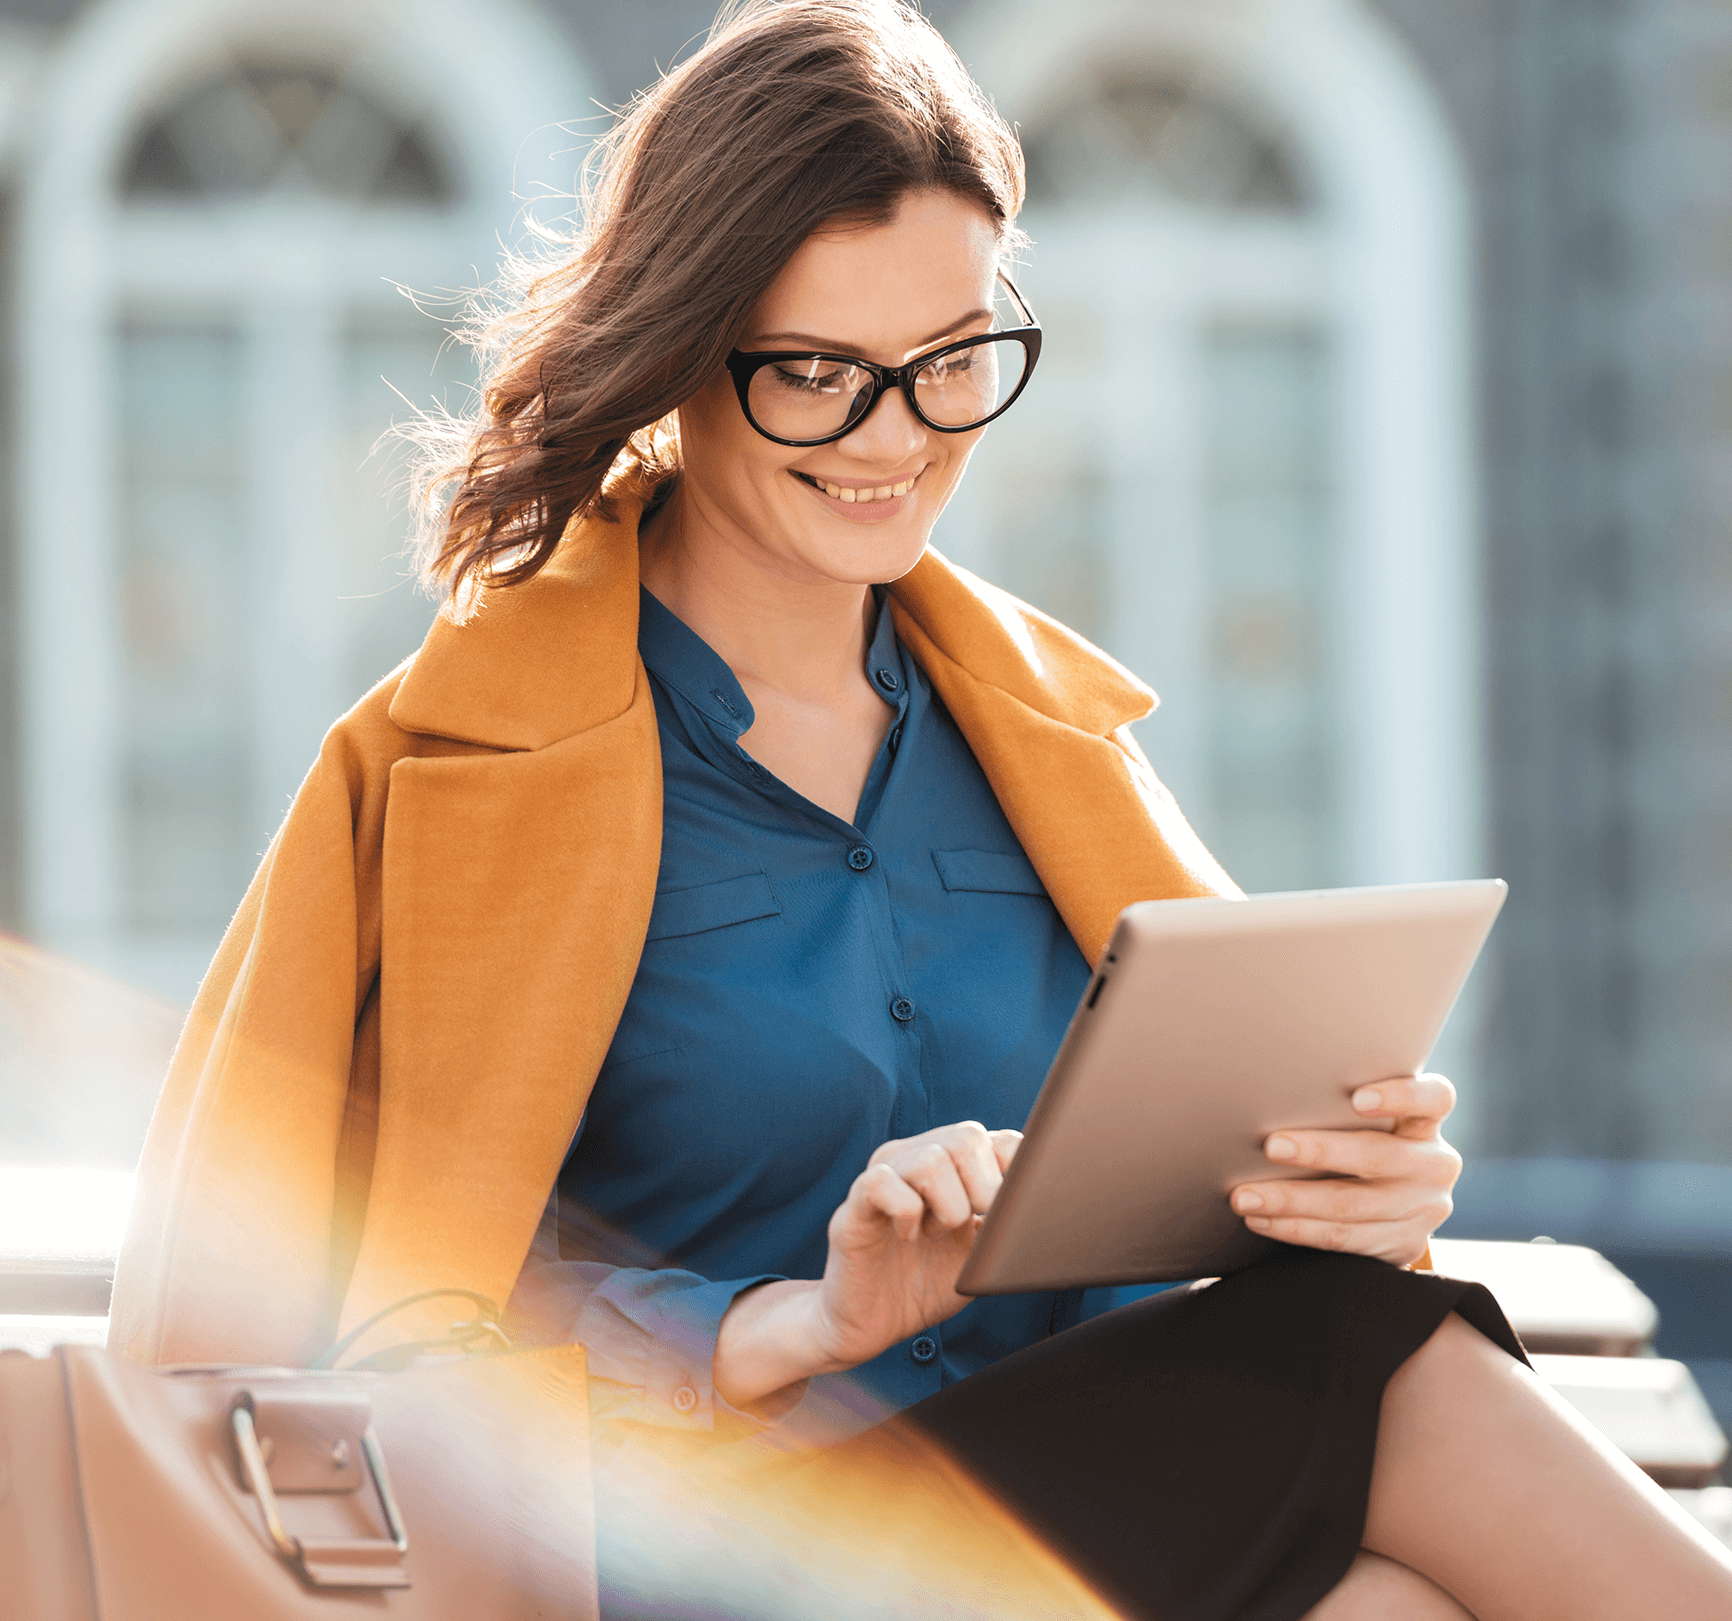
[109,681,402,1365]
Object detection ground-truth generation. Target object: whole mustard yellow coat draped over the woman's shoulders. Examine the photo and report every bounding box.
[109,488,1235,1365]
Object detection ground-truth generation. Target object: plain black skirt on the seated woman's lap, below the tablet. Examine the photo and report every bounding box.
[879,1249,1526,1621]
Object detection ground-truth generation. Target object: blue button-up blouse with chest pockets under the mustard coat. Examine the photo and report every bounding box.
[520,592,1156,1429]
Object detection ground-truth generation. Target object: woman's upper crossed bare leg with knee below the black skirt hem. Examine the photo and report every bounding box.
[1357,1313,1732,1621]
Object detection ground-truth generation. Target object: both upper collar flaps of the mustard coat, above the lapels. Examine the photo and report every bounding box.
[391,476,1157,750]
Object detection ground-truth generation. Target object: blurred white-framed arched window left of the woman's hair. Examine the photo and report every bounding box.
[19,0,587,1001]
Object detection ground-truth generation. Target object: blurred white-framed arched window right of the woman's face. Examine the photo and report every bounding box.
[935,0,1479,890]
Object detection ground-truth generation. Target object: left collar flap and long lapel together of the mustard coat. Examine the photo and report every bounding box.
[343,495,662,1339]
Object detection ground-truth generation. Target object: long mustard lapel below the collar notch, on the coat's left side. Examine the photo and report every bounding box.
[343,703,662,1337]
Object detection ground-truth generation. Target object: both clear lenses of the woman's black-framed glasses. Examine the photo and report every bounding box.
[746,336,1029,440]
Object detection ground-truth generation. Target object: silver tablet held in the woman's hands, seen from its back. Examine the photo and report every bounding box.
[956,880,1505,1294]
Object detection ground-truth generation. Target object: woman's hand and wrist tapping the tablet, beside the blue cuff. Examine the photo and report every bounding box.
[714,1120,1022,1406]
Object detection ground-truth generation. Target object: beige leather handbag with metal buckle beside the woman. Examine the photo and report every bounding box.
[0,1302,598,1621]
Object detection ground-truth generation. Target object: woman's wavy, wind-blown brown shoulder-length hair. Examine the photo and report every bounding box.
[405,0,1024,604]
